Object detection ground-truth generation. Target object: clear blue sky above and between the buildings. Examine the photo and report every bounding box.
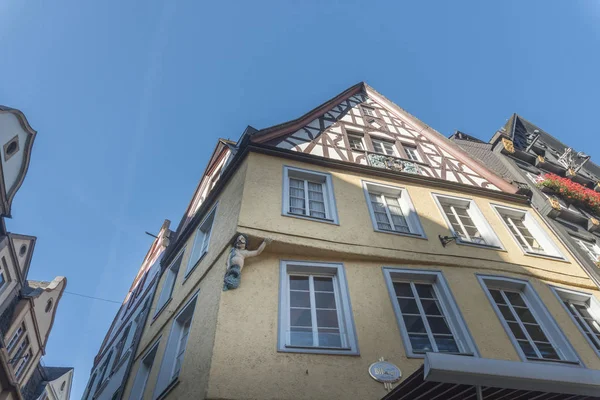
[0,0,600,399]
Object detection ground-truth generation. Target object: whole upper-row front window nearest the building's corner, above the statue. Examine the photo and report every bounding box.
[283,167,337,223]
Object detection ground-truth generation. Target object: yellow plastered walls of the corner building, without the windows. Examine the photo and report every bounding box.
[125,153,600,399]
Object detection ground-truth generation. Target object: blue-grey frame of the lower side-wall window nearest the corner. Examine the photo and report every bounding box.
[153,292,198,399]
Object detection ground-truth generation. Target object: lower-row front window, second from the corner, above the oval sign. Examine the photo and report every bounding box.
[383,268,477,357]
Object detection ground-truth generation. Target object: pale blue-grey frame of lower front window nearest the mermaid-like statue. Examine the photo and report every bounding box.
[277,260,359,355]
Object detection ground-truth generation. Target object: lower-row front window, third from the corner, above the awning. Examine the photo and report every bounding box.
[479,276,579,364]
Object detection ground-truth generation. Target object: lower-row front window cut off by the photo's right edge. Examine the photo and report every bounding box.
[551,286,600,356]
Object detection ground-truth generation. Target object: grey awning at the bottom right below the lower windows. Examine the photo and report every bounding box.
[382,353,600,400]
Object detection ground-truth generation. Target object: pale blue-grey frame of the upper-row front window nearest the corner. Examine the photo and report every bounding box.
[281,165,339,225]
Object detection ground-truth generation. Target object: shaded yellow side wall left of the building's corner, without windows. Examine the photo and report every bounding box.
[124,158,247,398]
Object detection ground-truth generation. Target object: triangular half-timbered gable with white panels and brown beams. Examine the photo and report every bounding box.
[252,83,513,192]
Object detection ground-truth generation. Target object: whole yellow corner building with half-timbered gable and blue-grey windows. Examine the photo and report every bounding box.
[123,84,600,399]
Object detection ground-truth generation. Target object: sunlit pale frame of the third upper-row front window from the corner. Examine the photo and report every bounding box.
[431,193,504,250]
